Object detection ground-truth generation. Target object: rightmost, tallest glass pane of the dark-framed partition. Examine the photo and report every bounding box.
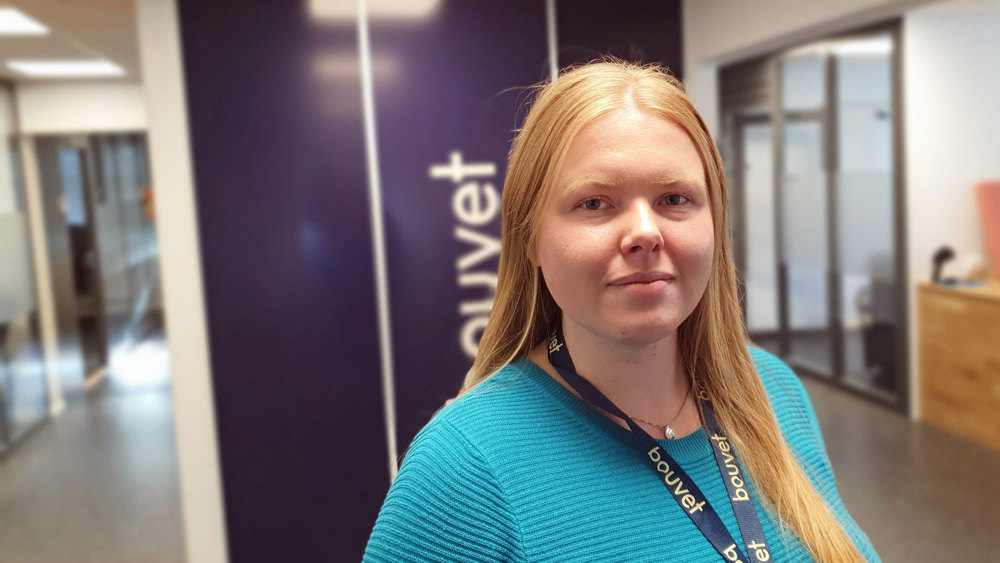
[834,38,899,390]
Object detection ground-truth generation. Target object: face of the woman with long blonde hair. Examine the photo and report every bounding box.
[536,109,715,345]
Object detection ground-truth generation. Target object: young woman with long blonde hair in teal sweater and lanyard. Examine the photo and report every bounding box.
[365,62,878,562]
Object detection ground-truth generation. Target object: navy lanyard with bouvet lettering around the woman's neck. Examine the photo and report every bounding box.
[548,329,771,563]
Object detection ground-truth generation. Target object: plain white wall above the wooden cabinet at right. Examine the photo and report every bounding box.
[903,1,1000,412]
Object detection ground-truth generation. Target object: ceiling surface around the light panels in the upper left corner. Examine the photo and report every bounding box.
[0,0,140,82]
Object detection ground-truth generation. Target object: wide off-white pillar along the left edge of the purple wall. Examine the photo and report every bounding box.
[136,0,228,563]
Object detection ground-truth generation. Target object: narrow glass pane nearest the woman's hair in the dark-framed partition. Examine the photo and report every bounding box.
[741,122,778,352]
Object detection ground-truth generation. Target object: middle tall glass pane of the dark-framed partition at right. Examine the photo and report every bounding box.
[782,120,831,374]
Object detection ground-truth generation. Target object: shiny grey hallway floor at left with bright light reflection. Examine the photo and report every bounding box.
[0,336,184,563]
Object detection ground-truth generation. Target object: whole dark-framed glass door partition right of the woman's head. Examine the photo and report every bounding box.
[720,26,907,410]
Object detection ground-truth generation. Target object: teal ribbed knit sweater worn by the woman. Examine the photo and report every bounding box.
[364,349,878,561]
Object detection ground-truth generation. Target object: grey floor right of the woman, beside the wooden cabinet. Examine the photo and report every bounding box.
[804,378,1000,562]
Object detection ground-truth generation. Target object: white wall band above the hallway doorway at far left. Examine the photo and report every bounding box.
[17,81,147,135]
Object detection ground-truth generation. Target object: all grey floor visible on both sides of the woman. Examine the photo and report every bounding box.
[0,340,1000,563]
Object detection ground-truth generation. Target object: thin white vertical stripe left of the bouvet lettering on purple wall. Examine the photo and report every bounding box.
[358,0,398,483]
